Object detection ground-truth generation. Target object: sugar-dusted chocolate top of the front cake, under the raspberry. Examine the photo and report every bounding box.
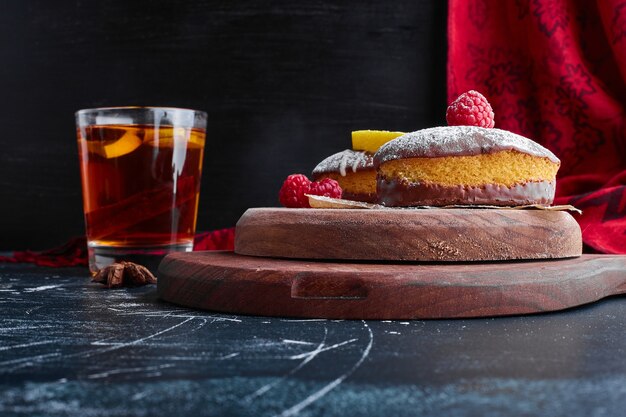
[374,126,560,166]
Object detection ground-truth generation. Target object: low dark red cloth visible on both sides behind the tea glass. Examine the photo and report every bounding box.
[0,227,235,267]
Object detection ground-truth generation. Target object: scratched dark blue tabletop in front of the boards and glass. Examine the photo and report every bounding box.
[0,264,626,417]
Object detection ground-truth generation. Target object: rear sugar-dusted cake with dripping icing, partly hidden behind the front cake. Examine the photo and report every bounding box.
[311,149,376,203]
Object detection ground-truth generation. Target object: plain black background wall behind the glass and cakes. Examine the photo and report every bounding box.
[0,0,446,250]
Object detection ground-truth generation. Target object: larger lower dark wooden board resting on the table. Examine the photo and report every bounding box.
[158,252,626,319]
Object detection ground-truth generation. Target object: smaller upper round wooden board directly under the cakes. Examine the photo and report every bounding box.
[235,208,582,262]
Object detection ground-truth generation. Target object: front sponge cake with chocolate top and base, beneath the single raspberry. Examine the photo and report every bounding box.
[374,126,560,207]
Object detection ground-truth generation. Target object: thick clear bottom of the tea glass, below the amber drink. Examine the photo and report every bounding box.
[87,242,193,275]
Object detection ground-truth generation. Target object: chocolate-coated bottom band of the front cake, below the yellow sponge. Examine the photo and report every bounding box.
[378,177,555,207]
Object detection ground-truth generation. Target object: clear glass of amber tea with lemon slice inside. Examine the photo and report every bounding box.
[76,107,207,274]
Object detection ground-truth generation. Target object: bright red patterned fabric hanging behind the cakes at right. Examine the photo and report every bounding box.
[448,0,626,253]
